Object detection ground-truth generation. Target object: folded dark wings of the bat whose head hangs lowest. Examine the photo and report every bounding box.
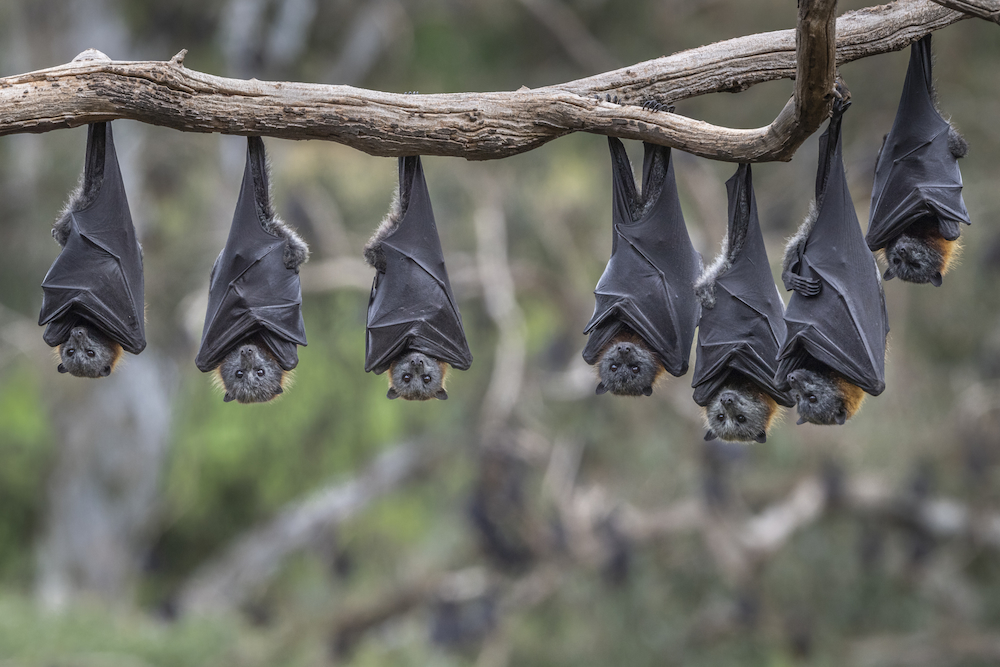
[691,164,795,407]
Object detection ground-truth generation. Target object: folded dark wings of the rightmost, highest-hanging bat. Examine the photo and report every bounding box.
[866,35,970,250]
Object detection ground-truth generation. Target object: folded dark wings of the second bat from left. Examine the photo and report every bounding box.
[195,137,306,372]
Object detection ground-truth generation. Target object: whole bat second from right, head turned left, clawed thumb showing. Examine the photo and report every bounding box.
[775,100,889,424]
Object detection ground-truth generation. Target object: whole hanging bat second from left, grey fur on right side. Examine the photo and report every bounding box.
[195,137,309,403]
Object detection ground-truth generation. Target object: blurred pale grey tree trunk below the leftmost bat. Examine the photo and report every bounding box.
[37,349,177,609]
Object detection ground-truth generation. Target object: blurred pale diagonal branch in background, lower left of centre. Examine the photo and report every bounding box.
[178,444,428,613]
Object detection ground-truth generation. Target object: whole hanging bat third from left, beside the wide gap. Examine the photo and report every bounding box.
[364,156,472,400]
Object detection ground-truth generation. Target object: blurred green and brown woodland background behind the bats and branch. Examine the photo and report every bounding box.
[0,0,1000,667]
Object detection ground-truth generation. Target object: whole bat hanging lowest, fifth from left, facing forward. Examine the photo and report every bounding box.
[691,164,794,443]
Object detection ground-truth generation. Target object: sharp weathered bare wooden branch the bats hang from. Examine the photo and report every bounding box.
[0,0,968,162]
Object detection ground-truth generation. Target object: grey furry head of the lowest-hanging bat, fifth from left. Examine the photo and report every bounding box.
[704,382,778,443]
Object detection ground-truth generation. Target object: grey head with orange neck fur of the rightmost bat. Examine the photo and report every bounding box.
[883,220,957,287]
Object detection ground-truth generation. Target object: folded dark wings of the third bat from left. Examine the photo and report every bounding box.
[365,156,472,374]
